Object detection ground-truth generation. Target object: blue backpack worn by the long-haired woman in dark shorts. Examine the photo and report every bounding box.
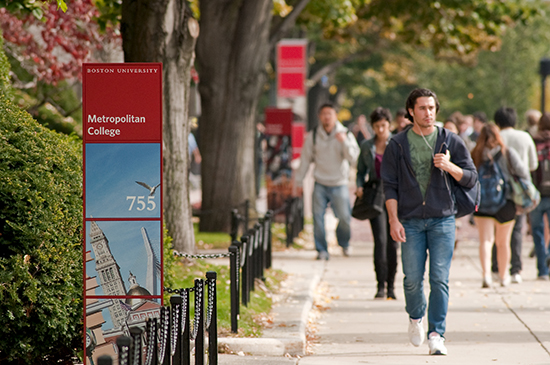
[478,152,506,215]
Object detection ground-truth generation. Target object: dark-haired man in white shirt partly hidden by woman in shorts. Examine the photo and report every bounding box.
[491,106,539,284]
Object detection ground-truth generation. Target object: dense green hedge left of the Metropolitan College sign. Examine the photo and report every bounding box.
[0,91,83,364]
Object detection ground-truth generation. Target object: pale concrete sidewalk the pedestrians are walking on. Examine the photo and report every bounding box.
[219,212,550,365]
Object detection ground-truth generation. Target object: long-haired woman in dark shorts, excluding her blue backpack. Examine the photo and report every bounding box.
[472,123,530,288]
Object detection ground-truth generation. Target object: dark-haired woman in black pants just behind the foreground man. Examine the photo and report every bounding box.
[355,107,397,299]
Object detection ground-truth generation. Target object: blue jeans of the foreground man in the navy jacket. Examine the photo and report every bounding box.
[401,216,455,336]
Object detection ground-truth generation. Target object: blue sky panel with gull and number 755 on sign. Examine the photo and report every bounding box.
[86,143,162,218]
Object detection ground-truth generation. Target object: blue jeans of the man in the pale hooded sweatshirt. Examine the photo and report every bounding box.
[312,183,351,252]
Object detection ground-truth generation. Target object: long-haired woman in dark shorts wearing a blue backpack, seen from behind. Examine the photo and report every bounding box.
[472,123,529,288]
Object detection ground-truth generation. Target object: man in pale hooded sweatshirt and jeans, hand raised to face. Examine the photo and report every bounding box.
[296,103,359,260]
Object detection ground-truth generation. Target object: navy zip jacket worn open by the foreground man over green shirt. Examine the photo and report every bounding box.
[381,127,477,219]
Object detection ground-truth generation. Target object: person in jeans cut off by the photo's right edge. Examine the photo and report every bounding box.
[529,113,550,280]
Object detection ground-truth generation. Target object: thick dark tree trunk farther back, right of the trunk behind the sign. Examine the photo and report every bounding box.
[197,0,273,232]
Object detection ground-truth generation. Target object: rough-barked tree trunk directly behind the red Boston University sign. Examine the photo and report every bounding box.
[121,0,196,253]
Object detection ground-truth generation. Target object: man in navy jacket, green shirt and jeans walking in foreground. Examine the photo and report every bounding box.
[382,89,477,355]
